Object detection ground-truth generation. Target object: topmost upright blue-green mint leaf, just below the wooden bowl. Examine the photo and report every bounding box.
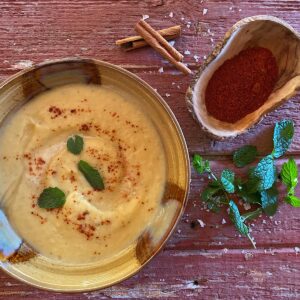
[272,120,294,158]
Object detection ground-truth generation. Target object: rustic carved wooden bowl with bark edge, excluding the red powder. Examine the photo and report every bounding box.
[186,16,300,139]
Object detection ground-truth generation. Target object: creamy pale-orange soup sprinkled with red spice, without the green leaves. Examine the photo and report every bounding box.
[0,84,166,264]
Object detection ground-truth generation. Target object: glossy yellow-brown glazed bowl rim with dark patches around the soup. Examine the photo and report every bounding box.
[0,58,190,291]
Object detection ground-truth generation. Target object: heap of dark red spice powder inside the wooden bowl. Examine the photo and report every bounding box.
[205,47,278,123]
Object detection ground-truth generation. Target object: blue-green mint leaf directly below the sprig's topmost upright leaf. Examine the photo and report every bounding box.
[250,155,276,191]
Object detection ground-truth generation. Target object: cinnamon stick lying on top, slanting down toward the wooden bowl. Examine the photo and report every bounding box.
[135,20,192,74]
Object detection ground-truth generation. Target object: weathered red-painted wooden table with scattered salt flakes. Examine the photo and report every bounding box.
[0,0,300,299]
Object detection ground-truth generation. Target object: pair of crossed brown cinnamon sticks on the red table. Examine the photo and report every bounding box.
[116,20,191,74]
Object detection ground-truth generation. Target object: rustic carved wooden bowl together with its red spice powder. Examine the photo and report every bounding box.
[186,16,300,139]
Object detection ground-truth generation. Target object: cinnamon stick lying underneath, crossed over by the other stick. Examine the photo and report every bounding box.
[116,25,181,51]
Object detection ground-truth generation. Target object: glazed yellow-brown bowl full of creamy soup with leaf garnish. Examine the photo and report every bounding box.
[0,58,190,291]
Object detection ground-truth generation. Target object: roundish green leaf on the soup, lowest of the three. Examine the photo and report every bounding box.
[37,187,66,208]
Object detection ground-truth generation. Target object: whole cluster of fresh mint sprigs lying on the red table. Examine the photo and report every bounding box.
[193,120,300,247]
